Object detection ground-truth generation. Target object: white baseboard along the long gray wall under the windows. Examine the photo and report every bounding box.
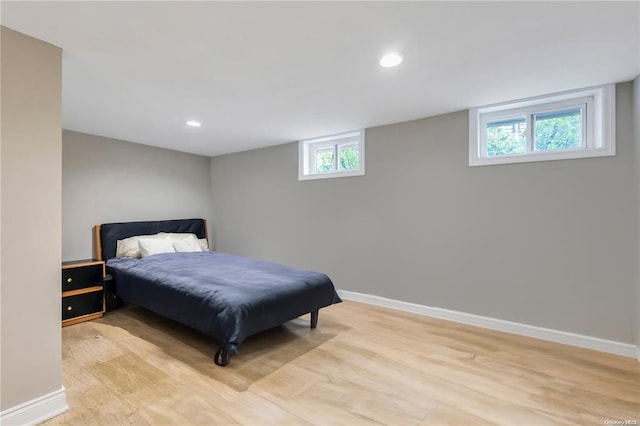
[338,290,640,361]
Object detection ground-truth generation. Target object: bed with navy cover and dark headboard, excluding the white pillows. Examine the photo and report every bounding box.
[94,219,341,366]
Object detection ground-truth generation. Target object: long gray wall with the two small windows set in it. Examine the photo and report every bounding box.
[211,84,638,343]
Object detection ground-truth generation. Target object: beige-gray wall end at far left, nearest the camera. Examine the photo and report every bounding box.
[0,27,66,411]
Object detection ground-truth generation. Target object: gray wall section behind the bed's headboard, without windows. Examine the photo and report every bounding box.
[62,130,213,260]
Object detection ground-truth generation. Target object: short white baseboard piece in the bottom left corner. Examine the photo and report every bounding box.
[0,386,69,426]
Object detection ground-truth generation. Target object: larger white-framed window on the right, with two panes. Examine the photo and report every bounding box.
[469,84,616,166]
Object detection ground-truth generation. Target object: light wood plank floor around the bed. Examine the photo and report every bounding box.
[46,302,640,425]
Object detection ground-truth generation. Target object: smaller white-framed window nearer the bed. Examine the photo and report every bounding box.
[298,130,364,180]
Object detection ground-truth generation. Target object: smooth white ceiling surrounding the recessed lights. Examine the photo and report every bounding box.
[1,0,640,156]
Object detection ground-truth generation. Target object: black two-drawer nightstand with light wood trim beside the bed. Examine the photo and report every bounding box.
[62,260,105,327]
